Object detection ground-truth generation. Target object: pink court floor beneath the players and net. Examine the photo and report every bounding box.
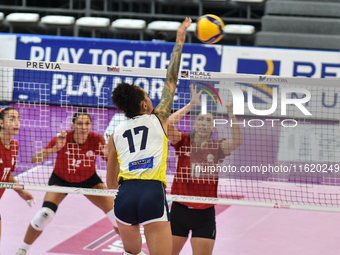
[0,185,340,255]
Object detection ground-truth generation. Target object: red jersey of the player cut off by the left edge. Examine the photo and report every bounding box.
[0,139,19,198]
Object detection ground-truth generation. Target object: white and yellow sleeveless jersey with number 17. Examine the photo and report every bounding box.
[113,114,168,187]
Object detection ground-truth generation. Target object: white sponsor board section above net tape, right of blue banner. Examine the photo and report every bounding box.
[221,46,340,78]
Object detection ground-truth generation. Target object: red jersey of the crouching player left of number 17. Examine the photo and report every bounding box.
[44,131,107,182]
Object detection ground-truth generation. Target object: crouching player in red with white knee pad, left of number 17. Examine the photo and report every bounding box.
[17,109,118,255]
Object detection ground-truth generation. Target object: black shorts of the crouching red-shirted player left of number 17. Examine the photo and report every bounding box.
[48,173,103,189]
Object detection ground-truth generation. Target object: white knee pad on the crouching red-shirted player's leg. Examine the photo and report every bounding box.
[31,202,57,231]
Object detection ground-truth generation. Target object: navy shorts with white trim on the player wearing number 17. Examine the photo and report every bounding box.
[114,179,170,226]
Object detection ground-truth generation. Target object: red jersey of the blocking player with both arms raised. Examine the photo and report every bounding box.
[171,133,227,209]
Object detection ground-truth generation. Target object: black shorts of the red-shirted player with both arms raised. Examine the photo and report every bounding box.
[170,202,216,240]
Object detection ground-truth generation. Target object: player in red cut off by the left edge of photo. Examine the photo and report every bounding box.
[0,107,35,249]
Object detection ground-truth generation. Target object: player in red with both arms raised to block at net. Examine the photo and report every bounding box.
[168,85,242,255]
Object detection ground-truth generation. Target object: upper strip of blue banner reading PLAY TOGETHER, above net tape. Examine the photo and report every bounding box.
[16,36,222,72]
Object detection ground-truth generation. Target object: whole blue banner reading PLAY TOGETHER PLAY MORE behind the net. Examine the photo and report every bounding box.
[1,34,222,108]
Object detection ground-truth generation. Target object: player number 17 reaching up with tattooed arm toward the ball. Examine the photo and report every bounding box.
[107,18,191,255]
